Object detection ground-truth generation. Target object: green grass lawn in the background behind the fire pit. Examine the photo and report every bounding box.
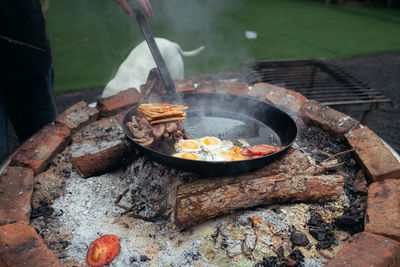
[47,0,400,93]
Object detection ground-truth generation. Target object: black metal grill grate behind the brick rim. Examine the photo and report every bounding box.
[240,59,391,111]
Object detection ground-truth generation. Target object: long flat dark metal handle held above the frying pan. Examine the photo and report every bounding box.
[134,9,176,95]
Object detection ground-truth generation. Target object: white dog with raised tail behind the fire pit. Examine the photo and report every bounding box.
[101,38,204,98]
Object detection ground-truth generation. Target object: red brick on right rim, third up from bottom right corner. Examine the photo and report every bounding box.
[345,126,400,181]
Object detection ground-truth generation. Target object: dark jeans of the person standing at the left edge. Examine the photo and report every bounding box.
[0,67,57,164]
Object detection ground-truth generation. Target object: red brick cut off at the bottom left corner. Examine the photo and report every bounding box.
[0,223,61,267]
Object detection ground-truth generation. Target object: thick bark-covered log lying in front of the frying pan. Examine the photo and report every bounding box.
[174,149,344,229]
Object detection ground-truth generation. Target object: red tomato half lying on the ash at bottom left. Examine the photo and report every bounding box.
[86,235,121,267]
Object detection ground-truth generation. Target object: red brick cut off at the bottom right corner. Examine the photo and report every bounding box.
[326,232,400,267]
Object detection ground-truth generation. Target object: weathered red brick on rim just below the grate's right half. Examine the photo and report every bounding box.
[301,100,359,138]
